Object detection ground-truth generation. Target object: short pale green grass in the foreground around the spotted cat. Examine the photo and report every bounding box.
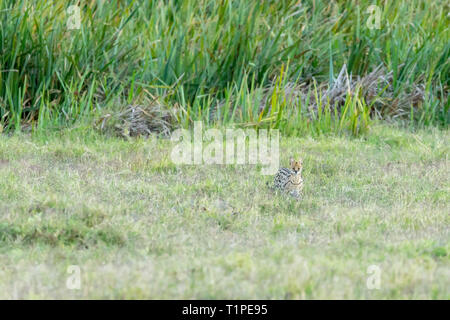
[0,125,450,299]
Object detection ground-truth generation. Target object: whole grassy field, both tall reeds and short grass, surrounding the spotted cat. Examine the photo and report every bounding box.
[0,0,450,299]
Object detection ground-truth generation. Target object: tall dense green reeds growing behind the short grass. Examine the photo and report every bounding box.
[0,0,450,135]
